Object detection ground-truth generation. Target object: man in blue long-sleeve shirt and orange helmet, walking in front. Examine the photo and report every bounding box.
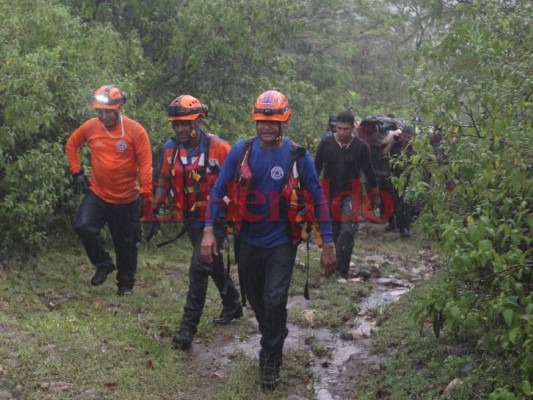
[201,90,336,390]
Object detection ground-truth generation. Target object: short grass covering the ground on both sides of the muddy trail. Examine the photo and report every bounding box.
[0,225,524,400]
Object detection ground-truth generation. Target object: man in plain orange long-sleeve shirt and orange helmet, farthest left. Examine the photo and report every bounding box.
[66,85,152,296]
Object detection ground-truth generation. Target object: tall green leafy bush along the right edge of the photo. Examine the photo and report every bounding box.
[410,1,533,399]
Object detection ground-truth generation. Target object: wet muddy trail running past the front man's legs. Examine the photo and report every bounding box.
[172,224,435,400]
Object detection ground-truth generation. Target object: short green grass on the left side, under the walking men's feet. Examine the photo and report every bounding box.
[0,223,420,400]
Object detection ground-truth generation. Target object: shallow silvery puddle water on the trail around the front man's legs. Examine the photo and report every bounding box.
[190,278,412,400]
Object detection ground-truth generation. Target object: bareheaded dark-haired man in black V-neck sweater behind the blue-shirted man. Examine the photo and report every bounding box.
[315,111,378,282]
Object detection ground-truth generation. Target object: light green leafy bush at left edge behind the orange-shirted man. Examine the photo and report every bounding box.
[0,0,150,257]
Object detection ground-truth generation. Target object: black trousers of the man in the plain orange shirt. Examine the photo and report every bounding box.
[74,191,141,288]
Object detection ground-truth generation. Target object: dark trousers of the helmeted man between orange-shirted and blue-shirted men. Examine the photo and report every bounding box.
[180,223,240,333]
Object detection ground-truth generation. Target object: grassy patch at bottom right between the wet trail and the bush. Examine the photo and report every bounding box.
[352,272,525,400]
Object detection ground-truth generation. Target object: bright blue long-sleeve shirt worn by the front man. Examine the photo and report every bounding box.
[205,138,332,249]
